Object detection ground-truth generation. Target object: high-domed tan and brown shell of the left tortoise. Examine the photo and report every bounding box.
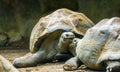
[30,8,94,53]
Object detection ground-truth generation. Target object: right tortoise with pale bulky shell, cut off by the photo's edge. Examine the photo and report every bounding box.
[63,17,120,72]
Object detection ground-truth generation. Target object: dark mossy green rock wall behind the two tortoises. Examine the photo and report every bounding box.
[0,0,120,48]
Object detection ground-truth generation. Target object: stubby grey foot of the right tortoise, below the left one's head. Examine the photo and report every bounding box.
[63,57,83,71]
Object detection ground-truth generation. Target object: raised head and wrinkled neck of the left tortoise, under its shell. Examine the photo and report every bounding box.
[55,32,75,60]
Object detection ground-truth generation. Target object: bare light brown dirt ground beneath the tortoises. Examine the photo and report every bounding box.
[0,49,103,72]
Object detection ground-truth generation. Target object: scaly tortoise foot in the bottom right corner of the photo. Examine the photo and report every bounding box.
[106,61,120,72]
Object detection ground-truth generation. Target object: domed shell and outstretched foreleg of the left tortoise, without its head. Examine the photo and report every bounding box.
[13,8,94,67]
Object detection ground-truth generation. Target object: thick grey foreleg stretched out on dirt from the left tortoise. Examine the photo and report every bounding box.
[13,50,45,67]
